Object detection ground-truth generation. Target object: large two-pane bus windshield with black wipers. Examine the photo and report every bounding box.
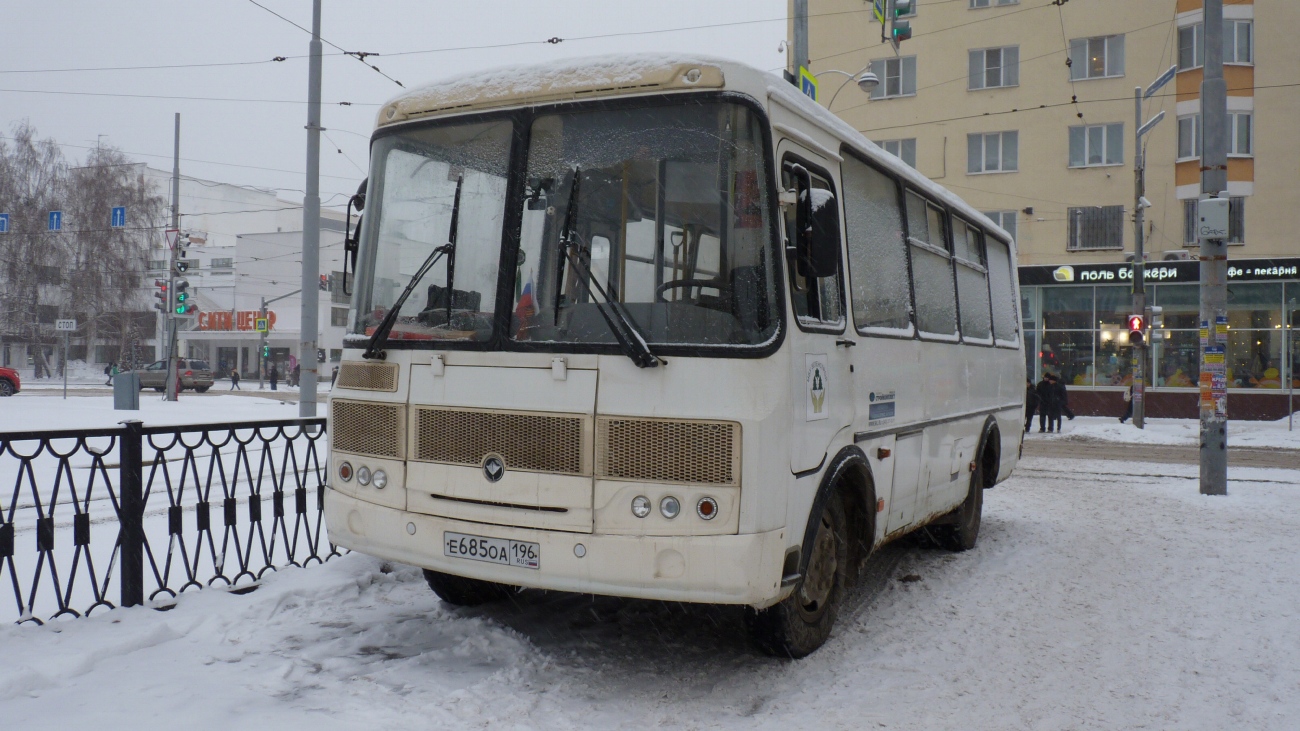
[350,100,780,349]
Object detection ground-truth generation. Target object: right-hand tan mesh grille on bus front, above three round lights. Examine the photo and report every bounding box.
[595,416,740,485]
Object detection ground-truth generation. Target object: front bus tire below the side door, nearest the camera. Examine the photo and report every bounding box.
[745,493,850,659]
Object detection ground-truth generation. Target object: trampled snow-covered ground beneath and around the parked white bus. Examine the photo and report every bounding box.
[0,455,1300,731]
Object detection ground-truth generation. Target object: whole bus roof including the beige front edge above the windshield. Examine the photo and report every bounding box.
[376,53,1011,242]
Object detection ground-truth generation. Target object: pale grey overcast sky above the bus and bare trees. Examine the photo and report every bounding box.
[0,0,787,206]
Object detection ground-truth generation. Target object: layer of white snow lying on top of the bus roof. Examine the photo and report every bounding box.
[377,53,1011,241]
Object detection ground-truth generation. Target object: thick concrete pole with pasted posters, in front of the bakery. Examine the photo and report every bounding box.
[1200,0,1227,496]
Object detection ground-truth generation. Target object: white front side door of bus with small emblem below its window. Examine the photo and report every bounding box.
[777,140,855,472]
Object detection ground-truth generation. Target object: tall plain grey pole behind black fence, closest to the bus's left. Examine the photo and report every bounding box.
[298,0,321,418]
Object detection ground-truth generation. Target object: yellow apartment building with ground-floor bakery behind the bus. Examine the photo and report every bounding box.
[790,0,1300,418]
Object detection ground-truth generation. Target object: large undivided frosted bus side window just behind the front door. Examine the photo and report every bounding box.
[841,156,913,336]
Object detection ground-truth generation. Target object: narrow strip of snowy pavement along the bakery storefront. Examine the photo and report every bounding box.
[1026,415,1300,449]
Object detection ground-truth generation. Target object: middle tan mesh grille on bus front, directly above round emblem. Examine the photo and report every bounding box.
[412,407,592,475]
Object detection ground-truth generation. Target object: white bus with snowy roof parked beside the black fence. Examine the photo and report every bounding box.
[325,56,1024,657]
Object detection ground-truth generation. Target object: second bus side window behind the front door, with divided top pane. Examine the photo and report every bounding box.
[906,190,957,341]
